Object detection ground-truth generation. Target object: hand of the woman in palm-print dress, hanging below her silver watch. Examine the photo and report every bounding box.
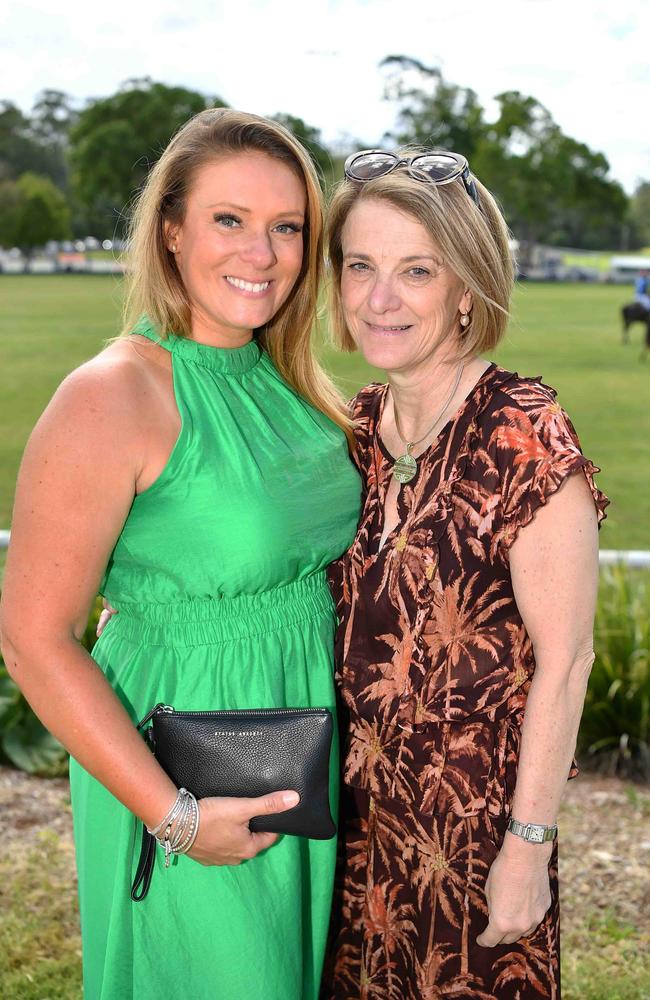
[476,834,552,948]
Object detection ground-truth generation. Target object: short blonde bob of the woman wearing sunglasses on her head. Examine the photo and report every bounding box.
[327,149,514,359]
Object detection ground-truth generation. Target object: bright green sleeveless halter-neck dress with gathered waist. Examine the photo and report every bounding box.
[70,324,361,1000]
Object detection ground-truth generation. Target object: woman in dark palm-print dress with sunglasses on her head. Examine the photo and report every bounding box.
[323,150,607,1000]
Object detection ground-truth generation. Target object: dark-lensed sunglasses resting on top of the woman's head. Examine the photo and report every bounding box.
[343,149,481,208]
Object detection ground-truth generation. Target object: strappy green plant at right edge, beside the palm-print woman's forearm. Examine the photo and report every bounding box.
[578,566,650,780]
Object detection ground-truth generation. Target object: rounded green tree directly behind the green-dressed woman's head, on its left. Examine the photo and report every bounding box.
[70,77,225,235]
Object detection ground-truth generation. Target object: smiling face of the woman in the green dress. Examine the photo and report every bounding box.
[166,152,307,347]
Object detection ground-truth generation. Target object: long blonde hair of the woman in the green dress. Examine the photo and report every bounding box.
[122,108,352,443]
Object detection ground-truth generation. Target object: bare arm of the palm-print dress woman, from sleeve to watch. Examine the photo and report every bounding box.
[508,473,598,832]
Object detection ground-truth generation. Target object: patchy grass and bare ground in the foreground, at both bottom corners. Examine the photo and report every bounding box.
[0,767,650,1000]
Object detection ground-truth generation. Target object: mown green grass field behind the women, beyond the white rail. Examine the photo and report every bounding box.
[0,275,650,549]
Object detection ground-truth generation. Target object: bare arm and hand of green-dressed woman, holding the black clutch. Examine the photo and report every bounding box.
[0,356,295,864]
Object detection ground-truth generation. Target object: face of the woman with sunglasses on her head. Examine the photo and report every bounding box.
[341,198,471,374]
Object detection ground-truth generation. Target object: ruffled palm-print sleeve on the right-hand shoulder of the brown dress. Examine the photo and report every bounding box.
[488,380,609,552]
